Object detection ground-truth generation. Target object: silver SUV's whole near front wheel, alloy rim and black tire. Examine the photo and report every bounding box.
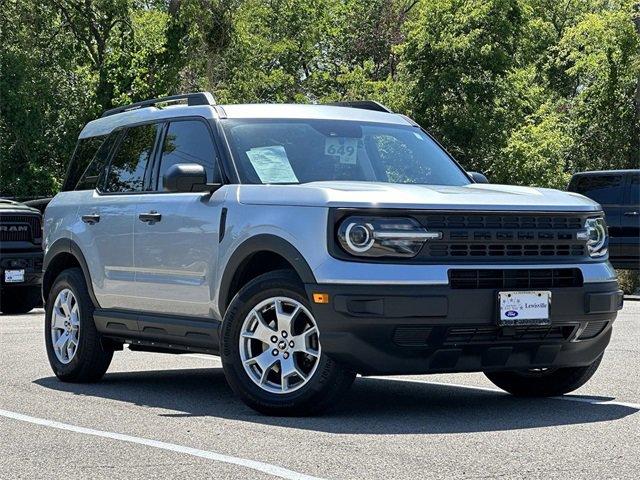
[221,270,355,415]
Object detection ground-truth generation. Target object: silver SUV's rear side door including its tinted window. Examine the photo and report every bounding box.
[78,124,160,309]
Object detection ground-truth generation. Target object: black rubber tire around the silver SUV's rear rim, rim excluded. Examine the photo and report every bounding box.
[44,270,95,377]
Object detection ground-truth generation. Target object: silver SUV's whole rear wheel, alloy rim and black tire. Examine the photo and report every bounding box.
[44,268,113,383]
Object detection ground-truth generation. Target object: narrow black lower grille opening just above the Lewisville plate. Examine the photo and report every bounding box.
[449,268,583,289]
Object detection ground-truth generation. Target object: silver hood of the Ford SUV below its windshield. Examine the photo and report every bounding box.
[237,182,601,212]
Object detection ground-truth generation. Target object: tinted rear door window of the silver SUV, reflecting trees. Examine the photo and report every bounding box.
[104,124,158,192]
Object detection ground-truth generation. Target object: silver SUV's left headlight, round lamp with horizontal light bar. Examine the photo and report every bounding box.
[338,217,442,257]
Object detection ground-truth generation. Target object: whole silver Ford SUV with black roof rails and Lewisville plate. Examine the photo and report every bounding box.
[43,93,622,415]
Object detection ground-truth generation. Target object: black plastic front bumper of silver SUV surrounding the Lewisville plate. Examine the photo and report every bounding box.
[306,281,623,375]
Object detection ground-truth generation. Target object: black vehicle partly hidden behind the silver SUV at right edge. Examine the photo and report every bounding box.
[569,170,640,270]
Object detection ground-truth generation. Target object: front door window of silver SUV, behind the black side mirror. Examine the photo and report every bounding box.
[158,121,220,190]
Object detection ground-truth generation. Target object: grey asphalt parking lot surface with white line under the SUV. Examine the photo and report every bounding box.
[0,302,640,479]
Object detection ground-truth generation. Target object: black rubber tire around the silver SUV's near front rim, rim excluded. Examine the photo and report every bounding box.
[221,273,335,410]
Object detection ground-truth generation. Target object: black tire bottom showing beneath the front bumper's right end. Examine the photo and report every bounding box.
[485,355,602,397]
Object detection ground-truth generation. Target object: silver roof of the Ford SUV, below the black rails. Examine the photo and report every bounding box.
[80,103,411,138]
